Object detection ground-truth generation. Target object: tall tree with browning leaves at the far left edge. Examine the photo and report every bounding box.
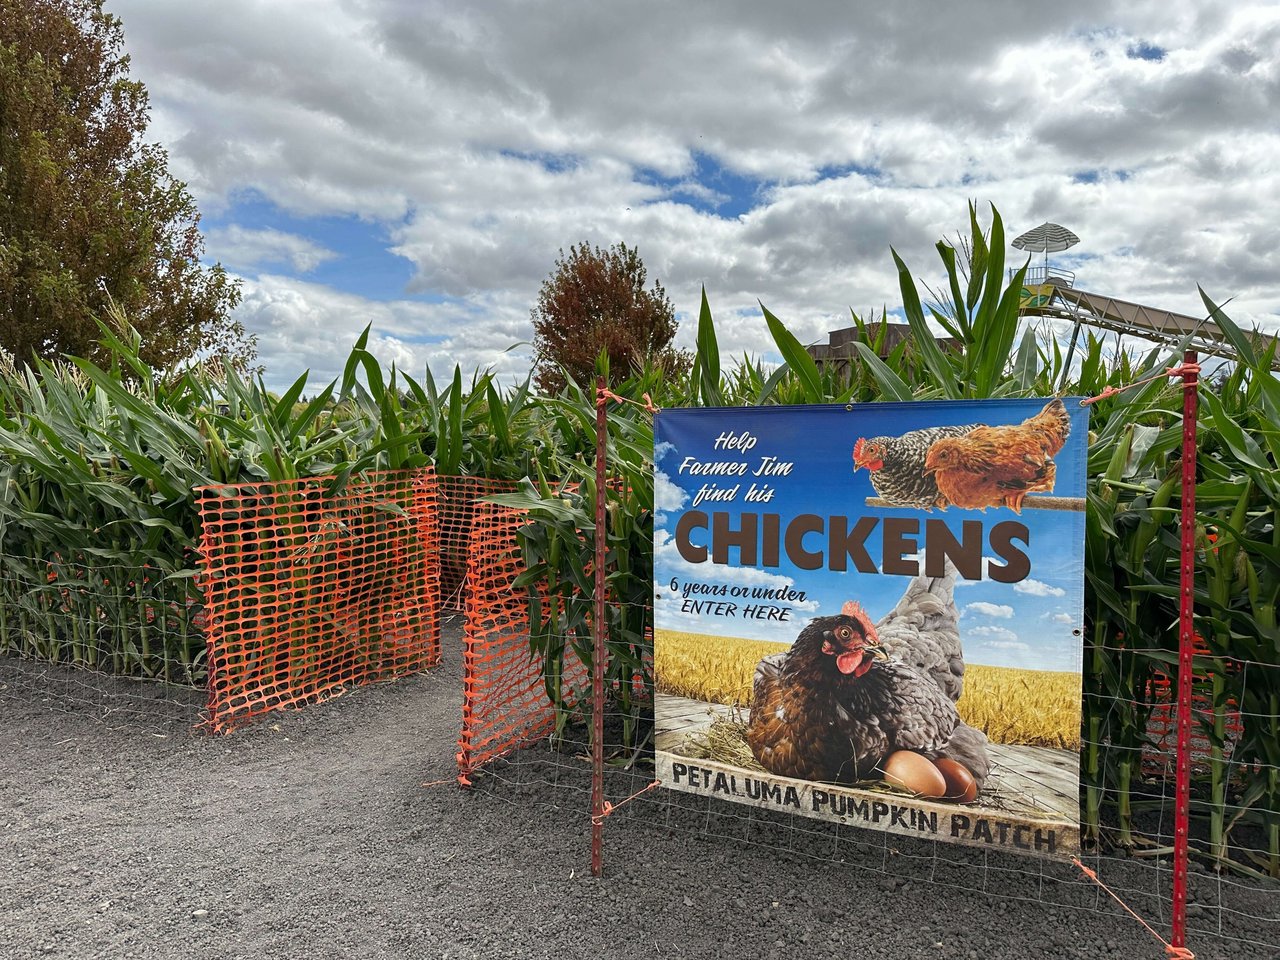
[0,0,253,367]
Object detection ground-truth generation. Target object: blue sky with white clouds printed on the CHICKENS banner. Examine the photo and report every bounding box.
[654,401,1088,672]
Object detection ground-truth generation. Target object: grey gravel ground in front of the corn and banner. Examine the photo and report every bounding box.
[0,622,1280,960]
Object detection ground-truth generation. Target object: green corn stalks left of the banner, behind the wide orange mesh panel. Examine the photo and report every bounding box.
[0,308,545,682]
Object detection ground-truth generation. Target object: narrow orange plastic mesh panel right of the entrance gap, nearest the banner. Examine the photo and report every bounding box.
[458,503,590,780]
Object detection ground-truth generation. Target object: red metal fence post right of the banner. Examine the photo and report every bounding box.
[1171,351,1199,947]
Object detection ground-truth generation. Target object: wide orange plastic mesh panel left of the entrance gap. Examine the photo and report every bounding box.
[197,470,440,731]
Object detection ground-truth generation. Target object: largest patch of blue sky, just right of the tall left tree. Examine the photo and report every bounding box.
[201,191,451,303]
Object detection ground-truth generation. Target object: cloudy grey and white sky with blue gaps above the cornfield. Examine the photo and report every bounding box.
[106,0,1280,385]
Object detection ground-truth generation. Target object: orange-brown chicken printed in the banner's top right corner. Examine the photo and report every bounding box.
[924,399,1071,513]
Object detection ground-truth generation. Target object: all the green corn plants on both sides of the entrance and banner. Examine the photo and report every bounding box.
[0,199,1280,876]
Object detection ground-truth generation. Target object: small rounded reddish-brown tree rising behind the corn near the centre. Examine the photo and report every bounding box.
[532,243,690,393]
